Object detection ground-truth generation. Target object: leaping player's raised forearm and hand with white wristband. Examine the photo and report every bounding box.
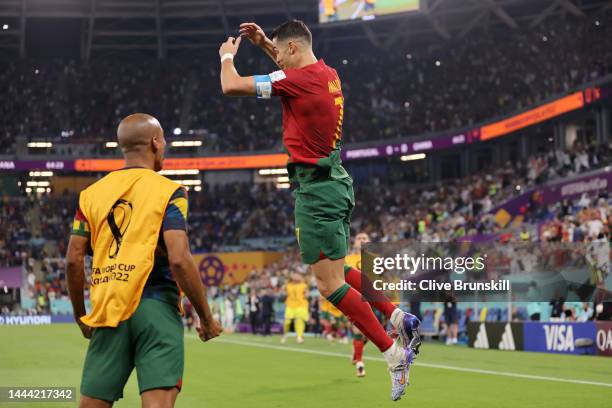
[219,37,256,96]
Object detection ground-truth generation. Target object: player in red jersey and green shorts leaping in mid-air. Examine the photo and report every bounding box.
[219,20,420,401]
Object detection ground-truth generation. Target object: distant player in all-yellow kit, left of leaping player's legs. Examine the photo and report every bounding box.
[281,272,308,344]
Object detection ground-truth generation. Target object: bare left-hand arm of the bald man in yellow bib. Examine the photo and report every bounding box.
[66,235,93,339]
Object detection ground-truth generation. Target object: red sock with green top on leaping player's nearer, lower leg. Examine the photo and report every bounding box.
[327,283,393,351]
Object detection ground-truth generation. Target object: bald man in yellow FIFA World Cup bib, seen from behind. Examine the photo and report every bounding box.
[66,113,222,408]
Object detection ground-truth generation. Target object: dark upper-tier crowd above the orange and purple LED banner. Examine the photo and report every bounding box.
[0,10,612,155]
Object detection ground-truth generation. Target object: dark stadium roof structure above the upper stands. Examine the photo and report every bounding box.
[0,0,612,58]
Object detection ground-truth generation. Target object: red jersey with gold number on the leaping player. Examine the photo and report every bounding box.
[269,59,344,164]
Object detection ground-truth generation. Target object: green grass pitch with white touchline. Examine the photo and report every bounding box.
[0,325,612,408]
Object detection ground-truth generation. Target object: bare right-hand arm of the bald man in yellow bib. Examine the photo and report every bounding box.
[164,230,223,341]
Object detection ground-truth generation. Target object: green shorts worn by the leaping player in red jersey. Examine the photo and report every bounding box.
[289,156,355,265]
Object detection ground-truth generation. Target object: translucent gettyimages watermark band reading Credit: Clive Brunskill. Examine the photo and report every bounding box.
[361,240,612,302]
